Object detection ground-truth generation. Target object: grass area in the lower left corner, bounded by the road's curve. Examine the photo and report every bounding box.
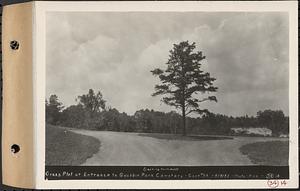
[46,125,100,166]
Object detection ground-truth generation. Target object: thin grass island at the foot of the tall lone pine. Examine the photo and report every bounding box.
[139,133,233,141]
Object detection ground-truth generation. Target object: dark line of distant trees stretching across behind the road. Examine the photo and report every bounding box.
[46,89,289,136]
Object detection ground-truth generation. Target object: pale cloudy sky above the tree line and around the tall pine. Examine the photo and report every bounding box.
[46,12,289,117]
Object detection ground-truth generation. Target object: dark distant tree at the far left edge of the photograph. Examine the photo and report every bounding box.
[46,95,64,125]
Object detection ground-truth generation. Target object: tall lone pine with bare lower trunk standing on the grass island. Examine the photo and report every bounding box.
[151,41,217,135]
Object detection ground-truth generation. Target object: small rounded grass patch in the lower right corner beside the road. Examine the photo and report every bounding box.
[240,141,289,166]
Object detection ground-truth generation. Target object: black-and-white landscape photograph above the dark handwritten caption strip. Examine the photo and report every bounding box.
[45,11,290,179]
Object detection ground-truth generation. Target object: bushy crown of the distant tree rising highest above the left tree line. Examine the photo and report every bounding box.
[77,89,106,114]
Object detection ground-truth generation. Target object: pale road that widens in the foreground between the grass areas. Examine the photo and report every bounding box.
[72,130,283,166]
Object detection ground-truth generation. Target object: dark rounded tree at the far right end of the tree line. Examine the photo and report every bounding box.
[257,109,286,136]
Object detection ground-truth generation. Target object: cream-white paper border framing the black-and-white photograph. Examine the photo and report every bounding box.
[33,1,298,189]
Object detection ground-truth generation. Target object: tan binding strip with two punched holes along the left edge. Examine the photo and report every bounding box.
[2,2,34,188]
